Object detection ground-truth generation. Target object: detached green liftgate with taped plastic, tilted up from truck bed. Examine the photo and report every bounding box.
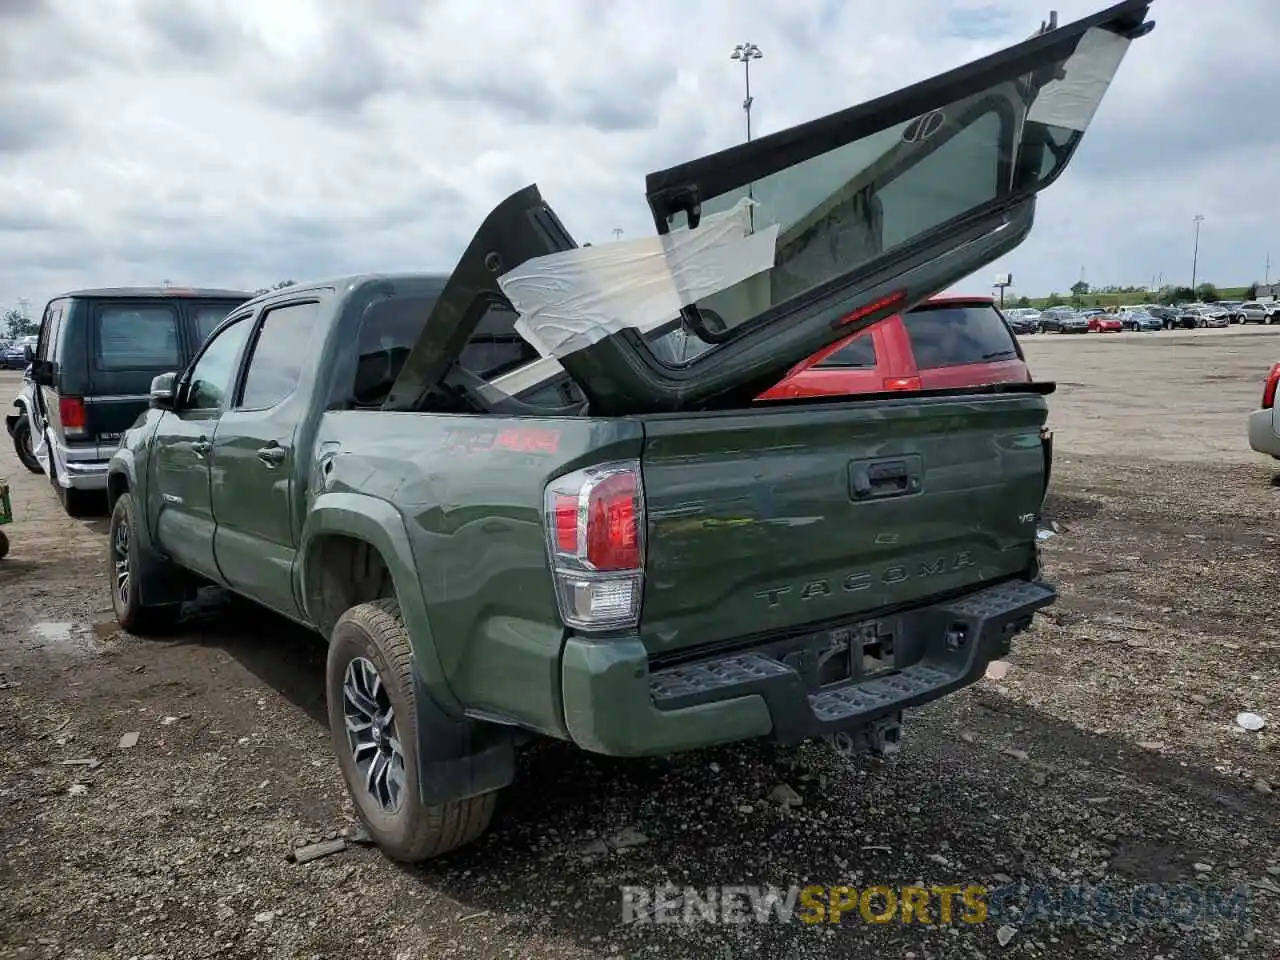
[500,0,1152,415]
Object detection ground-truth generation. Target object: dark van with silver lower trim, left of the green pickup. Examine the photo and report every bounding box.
[5,287,253,516]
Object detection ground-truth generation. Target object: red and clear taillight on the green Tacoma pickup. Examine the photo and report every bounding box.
[544,460,645,630]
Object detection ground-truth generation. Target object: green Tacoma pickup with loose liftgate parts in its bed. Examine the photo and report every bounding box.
[108,0,1151,860]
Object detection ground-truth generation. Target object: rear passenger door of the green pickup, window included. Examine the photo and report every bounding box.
[212,300,324,617]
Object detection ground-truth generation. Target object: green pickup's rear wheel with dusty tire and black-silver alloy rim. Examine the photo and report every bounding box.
[326,599,498,863]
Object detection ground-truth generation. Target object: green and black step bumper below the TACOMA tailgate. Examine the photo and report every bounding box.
[562,580,1057,756]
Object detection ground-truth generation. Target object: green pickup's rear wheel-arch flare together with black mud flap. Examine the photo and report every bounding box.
[298,492,516,805]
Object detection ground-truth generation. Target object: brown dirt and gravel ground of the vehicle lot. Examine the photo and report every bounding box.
[0,329,1280,960]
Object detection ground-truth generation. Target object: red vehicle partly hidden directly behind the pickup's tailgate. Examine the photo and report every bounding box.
[760,296,1032,399]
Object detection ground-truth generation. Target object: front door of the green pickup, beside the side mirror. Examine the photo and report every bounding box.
[147,315,252,582]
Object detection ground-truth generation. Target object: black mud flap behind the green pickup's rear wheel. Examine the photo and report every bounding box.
[413,680,516,806]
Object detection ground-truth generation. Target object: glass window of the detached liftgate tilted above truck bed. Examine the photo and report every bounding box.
[667,31,1119,350]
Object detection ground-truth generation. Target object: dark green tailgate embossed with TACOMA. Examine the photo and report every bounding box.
[640,392,1048,659]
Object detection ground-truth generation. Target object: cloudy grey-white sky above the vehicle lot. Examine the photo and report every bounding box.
[0,0,1280,316]
